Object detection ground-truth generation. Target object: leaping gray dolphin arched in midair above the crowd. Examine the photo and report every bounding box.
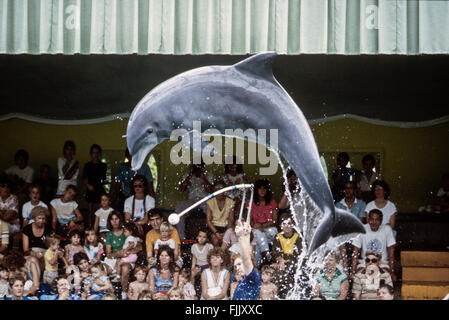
[126,52,365,254]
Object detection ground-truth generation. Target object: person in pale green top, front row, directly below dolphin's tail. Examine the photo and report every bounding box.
[314,251,349,300]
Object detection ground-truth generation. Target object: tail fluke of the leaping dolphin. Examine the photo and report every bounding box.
[307,208,365,255]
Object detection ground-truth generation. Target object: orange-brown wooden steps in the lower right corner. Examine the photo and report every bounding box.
[401,251,449,300]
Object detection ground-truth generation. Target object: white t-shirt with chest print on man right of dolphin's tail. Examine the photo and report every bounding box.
[352,224,396,265]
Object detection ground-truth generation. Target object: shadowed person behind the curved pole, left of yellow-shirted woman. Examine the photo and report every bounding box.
[175,159,214,239]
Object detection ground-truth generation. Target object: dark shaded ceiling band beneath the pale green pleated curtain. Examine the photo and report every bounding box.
[0,55,449,122]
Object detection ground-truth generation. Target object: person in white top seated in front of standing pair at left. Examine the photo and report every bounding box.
[50,185,83,237]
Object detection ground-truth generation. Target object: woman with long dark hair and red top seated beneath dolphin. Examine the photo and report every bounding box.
[246,179,278,243]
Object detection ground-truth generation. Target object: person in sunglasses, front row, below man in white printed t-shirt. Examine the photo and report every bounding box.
[352,252,393,300]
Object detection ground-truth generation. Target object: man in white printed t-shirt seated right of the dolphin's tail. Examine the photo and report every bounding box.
[351,209,396,281]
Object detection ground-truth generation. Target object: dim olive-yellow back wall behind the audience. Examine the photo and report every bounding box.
[0,119,449,212]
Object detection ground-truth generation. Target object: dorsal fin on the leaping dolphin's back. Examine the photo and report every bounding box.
[233,51,276,82]
